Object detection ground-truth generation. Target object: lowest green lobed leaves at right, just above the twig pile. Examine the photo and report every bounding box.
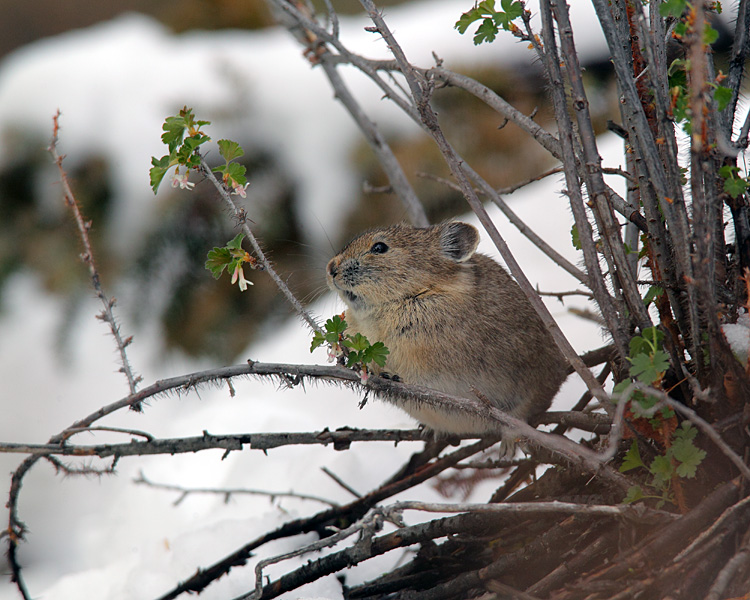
[620,421,706,508]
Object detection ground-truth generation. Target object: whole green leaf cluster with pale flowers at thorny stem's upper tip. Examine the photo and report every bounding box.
[149,106,247,197]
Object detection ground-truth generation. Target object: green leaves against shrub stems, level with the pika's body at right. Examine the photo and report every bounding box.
[614,326,674,420]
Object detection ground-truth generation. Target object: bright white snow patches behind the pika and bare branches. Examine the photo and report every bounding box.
[0,0,621,600]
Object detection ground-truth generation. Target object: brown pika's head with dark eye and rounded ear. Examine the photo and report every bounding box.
[326,222,479,310]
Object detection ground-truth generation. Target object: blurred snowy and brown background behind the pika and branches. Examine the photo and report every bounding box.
[0,0,731,600]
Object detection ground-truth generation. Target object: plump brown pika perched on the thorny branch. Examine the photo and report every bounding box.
[326,222,567,434]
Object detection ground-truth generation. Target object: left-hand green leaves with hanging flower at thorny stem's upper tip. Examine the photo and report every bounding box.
[149,106,211,193]
